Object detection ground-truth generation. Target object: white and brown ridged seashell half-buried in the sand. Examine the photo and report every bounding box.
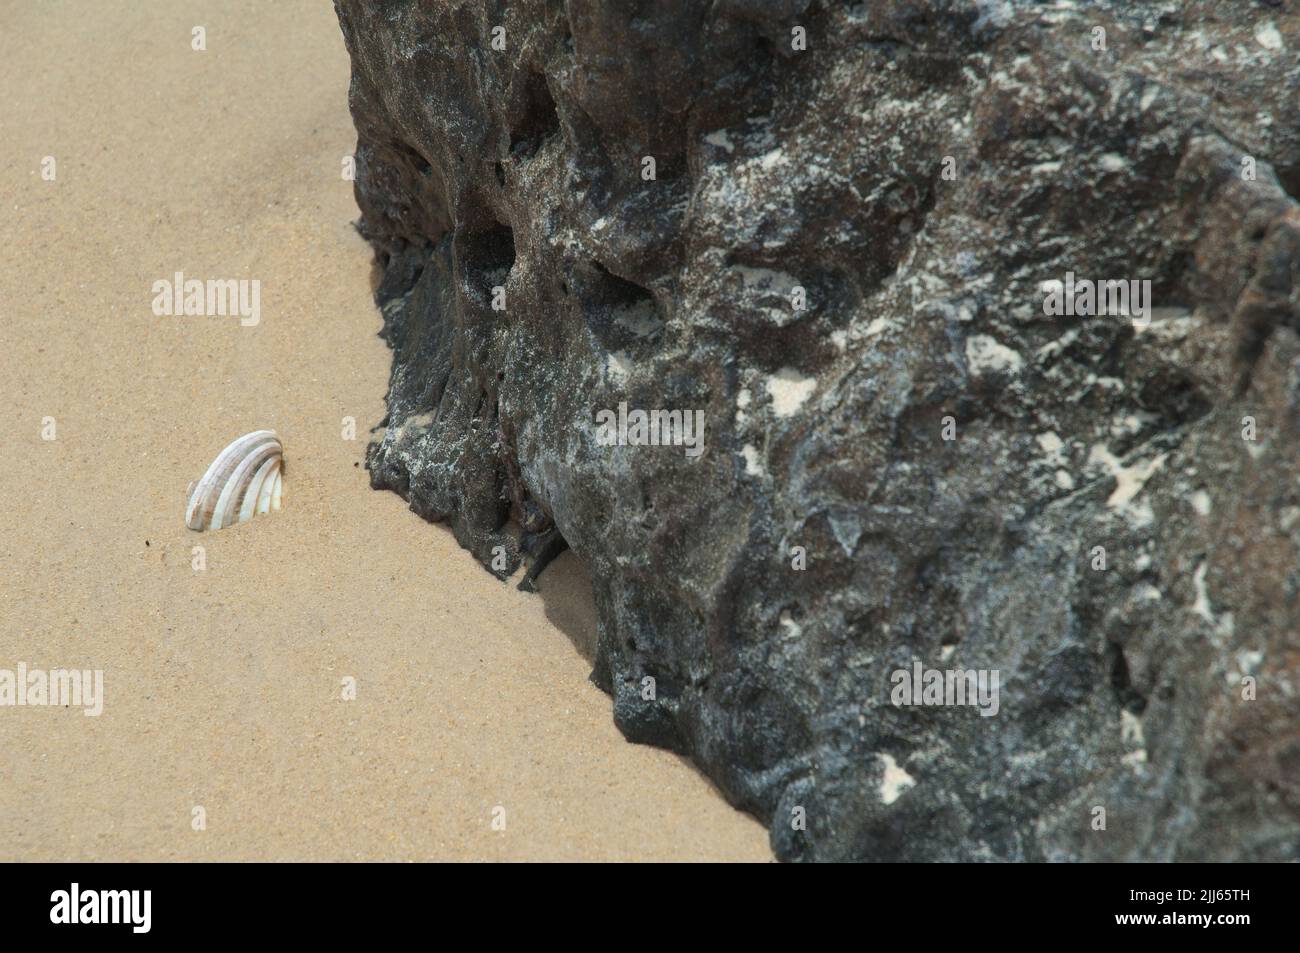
[185,430,285,532]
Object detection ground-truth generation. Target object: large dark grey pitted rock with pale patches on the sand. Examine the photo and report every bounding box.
[335,0,1300,861]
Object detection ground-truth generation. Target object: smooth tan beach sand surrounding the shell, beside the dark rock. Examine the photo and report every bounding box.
[0,0,771,861]
